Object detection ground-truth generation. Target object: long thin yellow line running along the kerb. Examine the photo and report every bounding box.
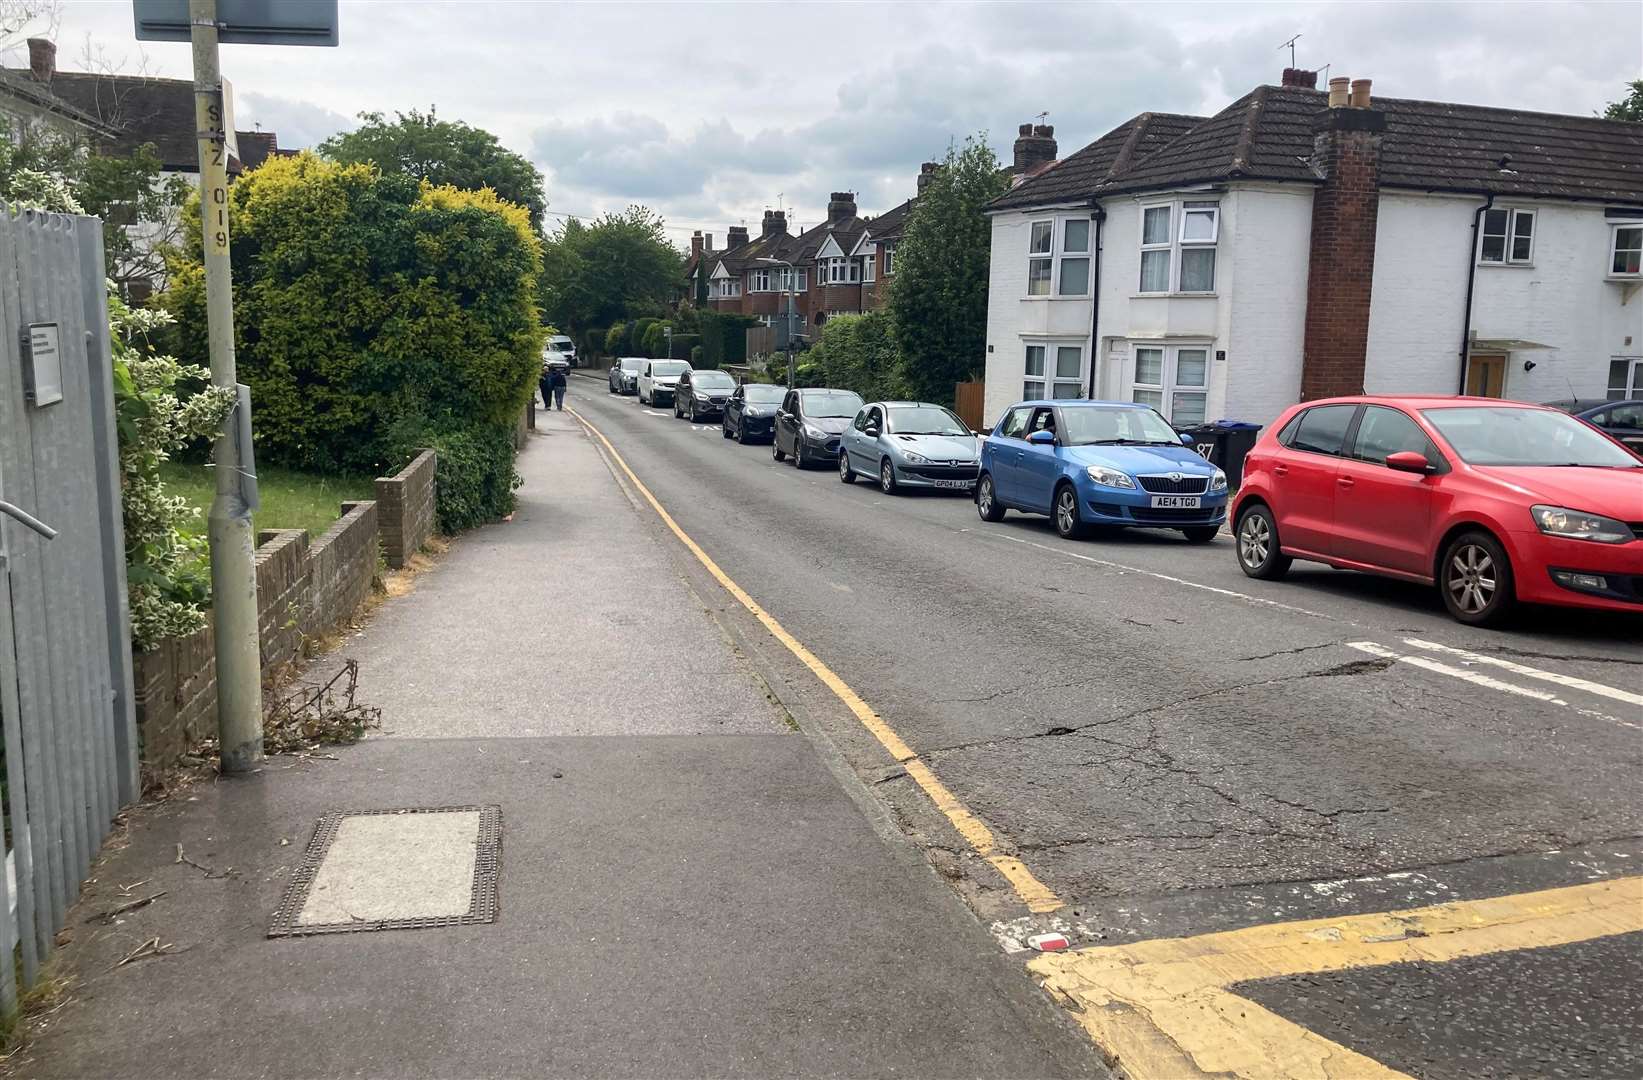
[565,409,1065,912]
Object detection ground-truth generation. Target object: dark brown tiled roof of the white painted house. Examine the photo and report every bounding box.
[991,85,1643,209]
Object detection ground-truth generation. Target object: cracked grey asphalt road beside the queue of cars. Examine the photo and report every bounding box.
[568,378,1643,1077]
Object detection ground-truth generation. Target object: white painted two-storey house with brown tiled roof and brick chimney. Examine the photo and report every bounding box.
[984,71,1643,426]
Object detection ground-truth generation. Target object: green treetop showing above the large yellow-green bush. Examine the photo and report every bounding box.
[319,107,547,230]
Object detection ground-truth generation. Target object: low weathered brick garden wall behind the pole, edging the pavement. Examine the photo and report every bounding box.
[133,503,382,768]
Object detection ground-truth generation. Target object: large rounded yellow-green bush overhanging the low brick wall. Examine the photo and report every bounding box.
[166,153,545,523]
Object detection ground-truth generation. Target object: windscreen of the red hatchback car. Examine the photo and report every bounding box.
[1421,404,1643,468]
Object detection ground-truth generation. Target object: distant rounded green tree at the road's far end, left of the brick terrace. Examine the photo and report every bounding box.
[542,205,683,332]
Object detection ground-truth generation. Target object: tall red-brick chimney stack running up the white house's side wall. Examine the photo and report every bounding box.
[1301,79,1387,401]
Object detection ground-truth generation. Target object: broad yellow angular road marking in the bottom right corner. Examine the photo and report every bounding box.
[1029,876,1643,1080]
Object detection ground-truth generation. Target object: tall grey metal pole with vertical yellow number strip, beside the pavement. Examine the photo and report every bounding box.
[189,0,263,773]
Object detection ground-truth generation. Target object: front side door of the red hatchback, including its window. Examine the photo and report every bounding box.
[1334,404,1447,577]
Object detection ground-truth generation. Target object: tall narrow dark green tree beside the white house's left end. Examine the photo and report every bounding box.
[889,133,1009,404]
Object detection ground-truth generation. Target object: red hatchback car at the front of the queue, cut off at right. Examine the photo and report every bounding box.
[1232,396,1643,625]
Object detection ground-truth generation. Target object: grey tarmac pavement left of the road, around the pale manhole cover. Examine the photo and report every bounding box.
[13,406,1101,1077]
